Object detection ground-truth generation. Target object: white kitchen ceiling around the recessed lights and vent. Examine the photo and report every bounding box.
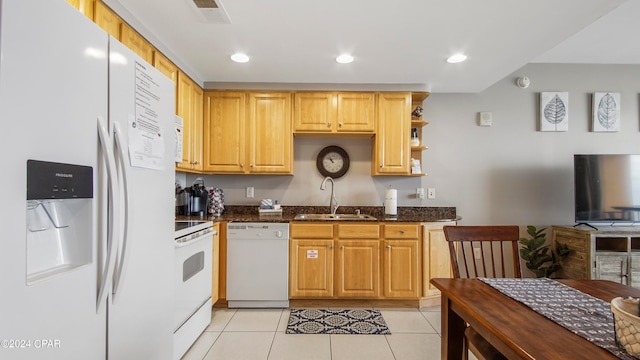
[105,0,640,92]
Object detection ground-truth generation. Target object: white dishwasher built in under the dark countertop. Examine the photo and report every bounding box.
[227,222,289,308]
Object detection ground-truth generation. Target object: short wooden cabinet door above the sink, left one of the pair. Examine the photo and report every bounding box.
[293,92,337,133]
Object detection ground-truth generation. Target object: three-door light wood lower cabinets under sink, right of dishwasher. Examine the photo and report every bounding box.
[289,223,422,299]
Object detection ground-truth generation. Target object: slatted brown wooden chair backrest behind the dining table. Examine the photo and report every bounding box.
[444,226,522,278]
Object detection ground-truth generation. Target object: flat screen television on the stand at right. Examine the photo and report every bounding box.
[573,154,640,224]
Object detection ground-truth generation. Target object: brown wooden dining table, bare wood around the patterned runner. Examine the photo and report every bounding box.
[431,278,640,360]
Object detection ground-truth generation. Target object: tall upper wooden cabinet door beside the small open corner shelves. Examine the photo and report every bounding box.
[372,93,411,175]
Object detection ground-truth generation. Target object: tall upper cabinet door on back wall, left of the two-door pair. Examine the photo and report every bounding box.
[203,91,246,173]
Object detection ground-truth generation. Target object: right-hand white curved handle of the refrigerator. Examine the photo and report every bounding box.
[113,123,129,303]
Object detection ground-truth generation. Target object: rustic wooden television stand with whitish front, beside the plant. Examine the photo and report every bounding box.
[551,224,640,288]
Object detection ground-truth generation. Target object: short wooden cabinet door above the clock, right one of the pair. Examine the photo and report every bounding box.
[336,92,376,133]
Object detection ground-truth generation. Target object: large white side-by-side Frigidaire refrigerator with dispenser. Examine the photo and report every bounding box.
[0,0,175,360]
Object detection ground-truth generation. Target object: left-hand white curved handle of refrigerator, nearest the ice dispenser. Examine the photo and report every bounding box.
[96,117,118,313]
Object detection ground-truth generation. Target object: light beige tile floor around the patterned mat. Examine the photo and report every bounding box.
[182,307,464,360]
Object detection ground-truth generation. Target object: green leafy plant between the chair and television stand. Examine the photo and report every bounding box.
[519,225,571,278]
